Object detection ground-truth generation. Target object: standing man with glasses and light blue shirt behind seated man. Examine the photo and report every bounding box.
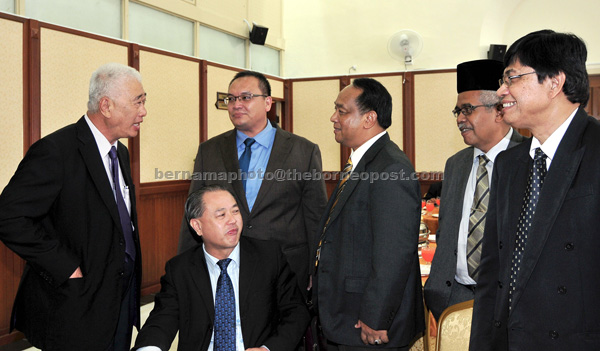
[179,71,327,293]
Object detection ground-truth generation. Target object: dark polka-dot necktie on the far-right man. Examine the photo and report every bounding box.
[508,147,546,309]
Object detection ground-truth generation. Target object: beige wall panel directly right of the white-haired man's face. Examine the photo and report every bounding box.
[140,51,200,183]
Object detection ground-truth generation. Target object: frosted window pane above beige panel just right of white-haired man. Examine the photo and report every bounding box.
[129,2,194,56]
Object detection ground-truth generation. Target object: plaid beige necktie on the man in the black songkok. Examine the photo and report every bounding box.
[467,154,490,281]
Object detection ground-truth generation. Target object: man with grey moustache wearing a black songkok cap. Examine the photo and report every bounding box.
[425,60,523,319]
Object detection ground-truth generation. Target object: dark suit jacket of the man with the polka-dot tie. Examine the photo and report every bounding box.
[470,108,600,351]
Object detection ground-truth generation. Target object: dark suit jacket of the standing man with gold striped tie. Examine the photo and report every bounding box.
[313,134,425,348]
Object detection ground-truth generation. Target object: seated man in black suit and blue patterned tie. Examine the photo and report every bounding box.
[134,185,309,351]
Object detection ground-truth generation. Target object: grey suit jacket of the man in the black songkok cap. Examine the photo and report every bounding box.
[424,130,525,319]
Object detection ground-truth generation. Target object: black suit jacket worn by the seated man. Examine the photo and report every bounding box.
[134,237,309,351]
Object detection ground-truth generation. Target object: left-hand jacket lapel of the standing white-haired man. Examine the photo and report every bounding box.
[76,117,121,232]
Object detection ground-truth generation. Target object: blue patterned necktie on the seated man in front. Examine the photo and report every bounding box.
[213,258,235,351]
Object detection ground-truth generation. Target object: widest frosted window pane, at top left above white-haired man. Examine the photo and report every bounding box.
[25,0,121,38]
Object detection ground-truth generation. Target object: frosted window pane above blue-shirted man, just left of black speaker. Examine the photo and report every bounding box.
[198,26,246,68]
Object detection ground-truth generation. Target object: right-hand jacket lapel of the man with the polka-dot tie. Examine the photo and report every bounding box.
[511,110,588,312]
